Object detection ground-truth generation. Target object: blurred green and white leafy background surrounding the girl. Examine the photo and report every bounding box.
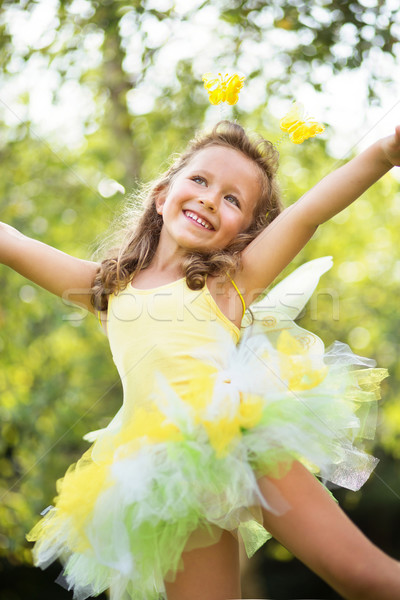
[0,0,400,600]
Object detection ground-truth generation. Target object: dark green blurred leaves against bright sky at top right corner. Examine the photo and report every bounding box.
[220,0,399,97]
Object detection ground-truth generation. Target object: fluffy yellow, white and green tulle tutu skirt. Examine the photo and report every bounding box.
[28,258,386,600]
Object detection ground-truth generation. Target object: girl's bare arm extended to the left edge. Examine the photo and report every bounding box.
[0,223,98,312]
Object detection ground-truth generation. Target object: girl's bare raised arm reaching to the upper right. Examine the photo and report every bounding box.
[235,126,400,304]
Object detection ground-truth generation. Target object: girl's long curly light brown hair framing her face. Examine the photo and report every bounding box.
[91,121,282,311]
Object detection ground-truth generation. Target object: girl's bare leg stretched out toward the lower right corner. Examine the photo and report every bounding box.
[259,463,400,600]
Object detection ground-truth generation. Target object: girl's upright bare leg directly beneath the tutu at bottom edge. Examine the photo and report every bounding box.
[165,531,241,600]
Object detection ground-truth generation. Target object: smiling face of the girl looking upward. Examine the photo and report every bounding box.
[156,146,261,251]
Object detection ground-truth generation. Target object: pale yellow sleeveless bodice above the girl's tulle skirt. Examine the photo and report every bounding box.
[108,278,240,410]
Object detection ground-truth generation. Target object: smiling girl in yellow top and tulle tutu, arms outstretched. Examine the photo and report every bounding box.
[0,122,400,600]
